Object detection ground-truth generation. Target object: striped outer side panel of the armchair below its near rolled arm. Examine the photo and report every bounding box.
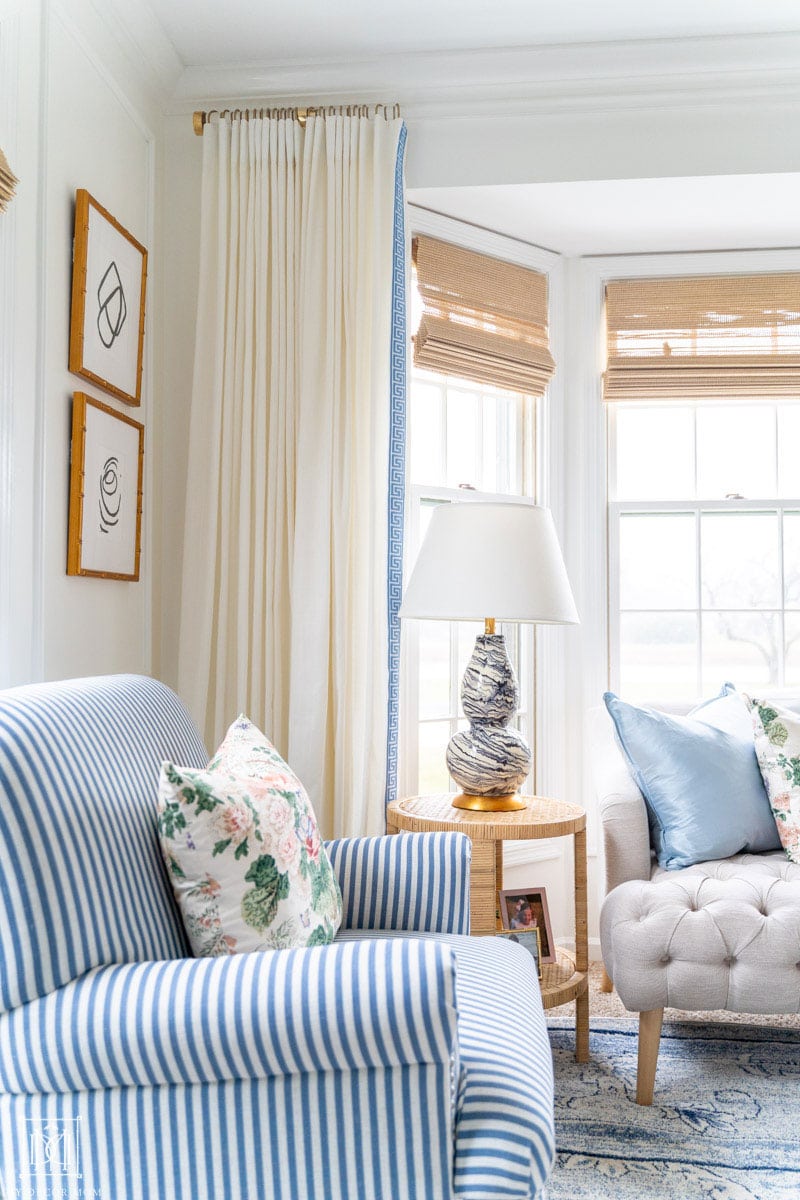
[0,1064,455,1200]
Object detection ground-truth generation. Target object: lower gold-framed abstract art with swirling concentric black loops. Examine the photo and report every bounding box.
[67,391,144,580]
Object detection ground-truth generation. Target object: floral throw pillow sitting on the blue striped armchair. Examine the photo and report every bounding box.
[158,716,342,956]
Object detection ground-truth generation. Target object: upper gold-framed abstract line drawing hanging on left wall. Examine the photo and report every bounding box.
[70,188,148,404]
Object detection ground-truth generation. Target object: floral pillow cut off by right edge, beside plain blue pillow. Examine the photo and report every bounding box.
[750,700,800,863]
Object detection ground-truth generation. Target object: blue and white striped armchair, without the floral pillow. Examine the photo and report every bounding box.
[0,676,554,1200]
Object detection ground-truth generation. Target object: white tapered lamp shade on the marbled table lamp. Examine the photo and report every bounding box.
[399,503,578,625]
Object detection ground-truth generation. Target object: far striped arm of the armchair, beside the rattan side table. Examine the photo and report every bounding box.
[326,833,473,934]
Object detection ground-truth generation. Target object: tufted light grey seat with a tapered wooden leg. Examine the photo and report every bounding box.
[601,852,800,1104]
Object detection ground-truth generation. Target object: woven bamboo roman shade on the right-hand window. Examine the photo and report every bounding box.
[603,272,800,401]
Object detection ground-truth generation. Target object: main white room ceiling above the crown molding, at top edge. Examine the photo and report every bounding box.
[149,0,800,67]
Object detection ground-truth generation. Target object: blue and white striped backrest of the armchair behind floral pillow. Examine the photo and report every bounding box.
[0,676,207,1012]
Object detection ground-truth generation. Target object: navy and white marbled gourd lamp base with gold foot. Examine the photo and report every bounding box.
[446,634,531,812]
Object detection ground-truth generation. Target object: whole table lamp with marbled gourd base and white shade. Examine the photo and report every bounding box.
[399,502,578,812]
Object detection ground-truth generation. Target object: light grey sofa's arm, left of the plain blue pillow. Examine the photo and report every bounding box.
[589,708,652,895]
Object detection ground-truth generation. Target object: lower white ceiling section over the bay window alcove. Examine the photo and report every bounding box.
[409,174,800,254]
